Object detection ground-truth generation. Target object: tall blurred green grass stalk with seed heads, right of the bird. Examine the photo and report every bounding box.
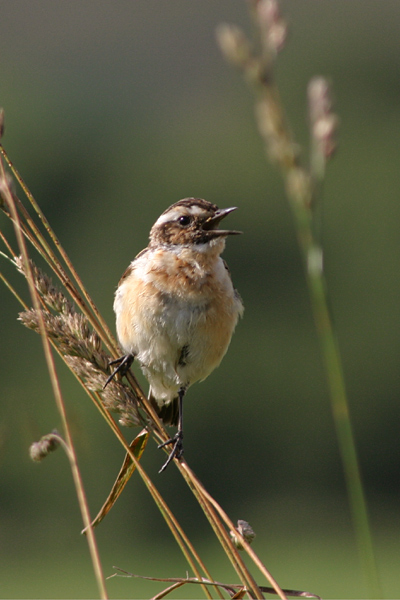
[217,0,381,598]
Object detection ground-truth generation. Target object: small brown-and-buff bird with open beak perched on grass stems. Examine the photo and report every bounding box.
[105,198,244,473]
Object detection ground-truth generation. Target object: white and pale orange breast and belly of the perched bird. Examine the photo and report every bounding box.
[114,246,243,404]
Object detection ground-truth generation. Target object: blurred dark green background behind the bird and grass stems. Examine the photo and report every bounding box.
[0,0,400,598]
